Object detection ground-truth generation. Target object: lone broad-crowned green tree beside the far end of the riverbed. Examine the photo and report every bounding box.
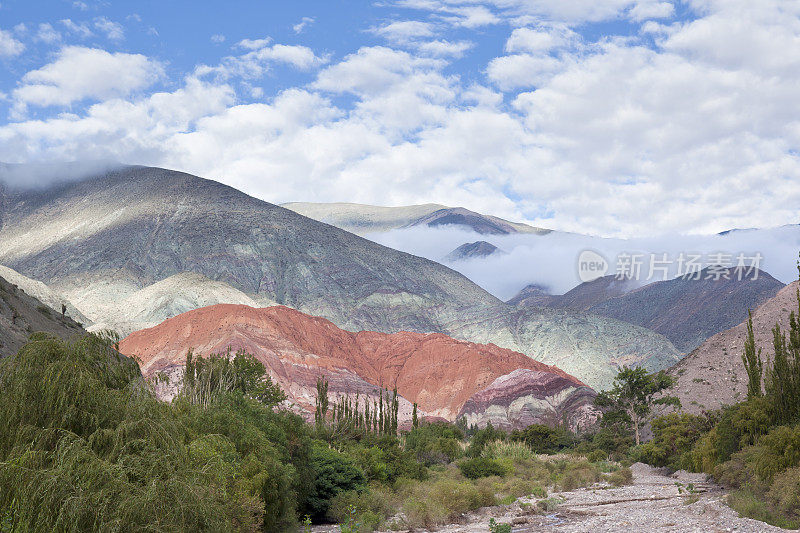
[595,367,680,446]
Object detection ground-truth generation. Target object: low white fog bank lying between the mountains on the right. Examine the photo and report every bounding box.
[367,225,800,300]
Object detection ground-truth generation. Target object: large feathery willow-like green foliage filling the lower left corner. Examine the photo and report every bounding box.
[0,335,272,531]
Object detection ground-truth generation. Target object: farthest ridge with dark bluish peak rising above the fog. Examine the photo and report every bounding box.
[282,202,550,235]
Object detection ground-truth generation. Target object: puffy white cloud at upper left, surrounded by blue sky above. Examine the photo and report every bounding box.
[13,46,164,110]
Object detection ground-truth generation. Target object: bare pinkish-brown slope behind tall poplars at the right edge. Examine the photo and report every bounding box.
[669,281,798,413]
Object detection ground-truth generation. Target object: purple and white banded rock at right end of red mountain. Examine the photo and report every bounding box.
[459,369,599,431]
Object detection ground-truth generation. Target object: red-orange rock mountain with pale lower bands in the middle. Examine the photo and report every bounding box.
[120,304,594,428]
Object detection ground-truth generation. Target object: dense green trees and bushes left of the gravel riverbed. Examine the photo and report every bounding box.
[0,334,629,532]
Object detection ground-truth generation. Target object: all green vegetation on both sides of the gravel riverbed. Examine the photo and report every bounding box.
[7,260,800,532]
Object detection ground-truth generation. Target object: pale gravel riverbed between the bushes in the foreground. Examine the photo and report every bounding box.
[315,463,787,533]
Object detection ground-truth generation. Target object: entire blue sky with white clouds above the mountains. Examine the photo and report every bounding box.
[0,0,800,238]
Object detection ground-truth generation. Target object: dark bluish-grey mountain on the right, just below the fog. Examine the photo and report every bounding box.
[588,269,784,353]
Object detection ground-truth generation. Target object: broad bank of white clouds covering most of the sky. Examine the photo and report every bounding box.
[0,0,800,239]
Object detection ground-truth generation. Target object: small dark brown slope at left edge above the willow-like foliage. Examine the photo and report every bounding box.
[0,277,85,359]
